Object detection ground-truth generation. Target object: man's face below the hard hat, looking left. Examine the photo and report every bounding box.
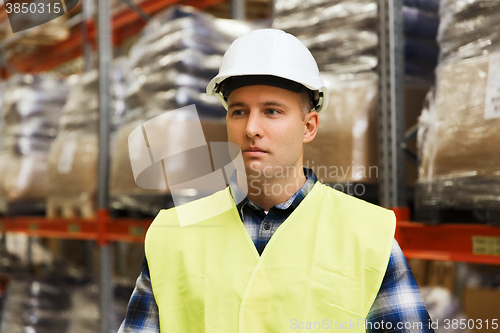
[226,85,317,178]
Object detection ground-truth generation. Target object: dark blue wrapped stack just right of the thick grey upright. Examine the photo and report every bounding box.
[403,0,439,84]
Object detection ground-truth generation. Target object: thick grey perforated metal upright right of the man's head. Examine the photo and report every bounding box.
[379,0,407,211]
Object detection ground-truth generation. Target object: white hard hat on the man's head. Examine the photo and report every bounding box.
[207,29,328,113]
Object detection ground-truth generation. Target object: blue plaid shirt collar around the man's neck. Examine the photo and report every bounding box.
[229,167,318,212]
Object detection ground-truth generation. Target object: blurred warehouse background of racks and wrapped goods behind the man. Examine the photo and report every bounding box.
[0,0,500,333]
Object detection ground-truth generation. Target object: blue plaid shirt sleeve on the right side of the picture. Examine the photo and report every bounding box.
[366,240,434,333]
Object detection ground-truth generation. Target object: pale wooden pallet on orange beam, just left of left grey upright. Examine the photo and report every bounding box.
[46,197,96,219]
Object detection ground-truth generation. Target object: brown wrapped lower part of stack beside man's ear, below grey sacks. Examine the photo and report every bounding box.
[304,73,378,183]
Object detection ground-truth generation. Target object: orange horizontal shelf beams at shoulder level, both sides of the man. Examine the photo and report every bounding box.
[0,214,500,265]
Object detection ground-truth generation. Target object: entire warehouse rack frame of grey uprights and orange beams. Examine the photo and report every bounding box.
[0,0,500,332]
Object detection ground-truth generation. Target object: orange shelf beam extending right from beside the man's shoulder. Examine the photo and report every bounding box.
[396,221,500,265]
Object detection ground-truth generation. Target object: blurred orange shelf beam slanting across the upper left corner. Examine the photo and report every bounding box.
[0,0,226,73]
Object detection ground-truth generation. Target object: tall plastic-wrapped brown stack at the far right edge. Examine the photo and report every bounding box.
[416,0,500,222]
